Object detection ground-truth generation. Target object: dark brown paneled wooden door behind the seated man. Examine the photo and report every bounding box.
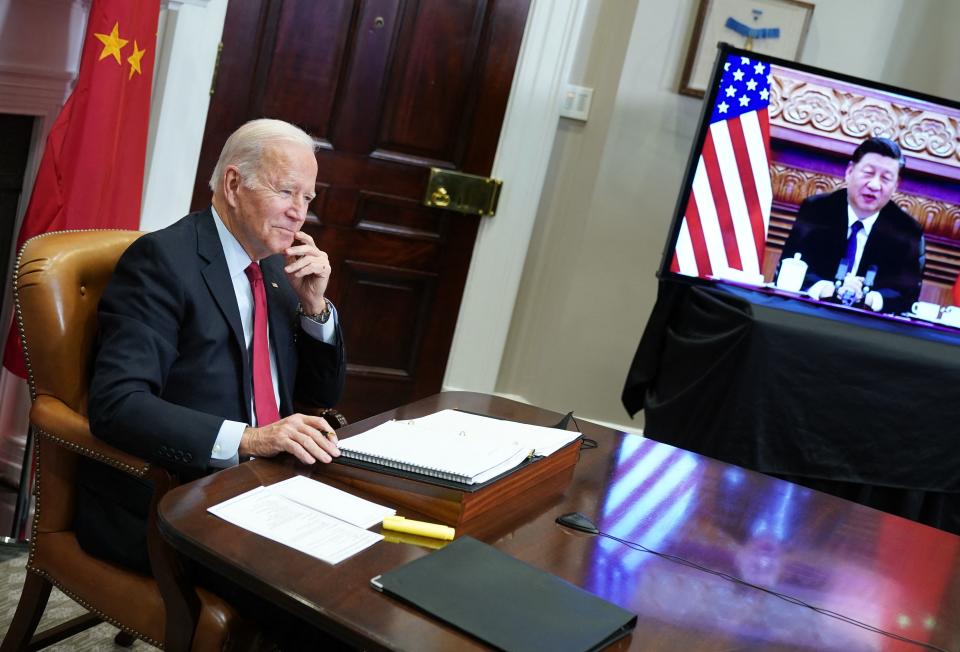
[193,0,530,420]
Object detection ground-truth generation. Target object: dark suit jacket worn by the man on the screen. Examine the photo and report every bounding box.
[781,189,924,312]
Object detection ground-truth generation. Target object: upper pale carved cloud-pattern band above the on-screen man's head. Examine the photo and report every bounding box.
[769,68,960,169]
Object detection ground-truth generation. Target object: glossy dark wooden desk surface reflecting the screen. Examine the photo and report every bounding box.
[159,392,960,652]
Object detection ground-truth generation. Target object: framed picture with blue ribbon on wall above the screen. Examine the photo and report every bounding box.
[680,0,813,97]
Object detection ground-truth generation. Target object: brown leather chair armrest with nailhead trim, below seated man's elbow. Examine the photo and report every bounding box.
[30,394,150,478]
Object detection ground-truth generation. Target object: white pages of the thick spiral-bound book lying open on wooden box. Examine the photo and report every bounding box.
[339,410,580,485]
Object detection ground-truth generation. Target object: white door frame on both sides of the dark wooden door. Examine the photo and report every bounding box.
[140,0,587,393]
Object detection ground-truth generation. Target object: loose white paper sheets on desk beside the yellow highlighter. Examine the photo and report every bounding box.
[207,475,396,564]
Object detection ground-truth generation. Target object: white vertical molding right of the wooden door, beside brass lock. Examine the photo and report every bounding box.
[443,0,587,393]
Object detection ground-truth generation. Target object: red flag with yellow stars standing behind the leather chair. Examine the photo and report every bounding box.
[4,0,160,378]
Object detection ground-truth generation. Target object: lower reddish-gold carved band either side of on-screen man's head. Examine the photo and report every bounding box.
[770,163,960,240]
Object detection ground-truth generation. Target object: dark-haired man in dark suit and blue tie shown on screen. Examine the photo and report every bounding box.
[781,137,924,313]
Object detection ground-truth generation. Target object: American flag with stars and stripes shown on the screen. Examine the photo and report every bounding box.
[670,55,773,277]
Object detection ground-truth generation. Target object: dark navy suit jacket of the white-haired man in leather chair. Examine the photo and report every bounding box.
[77,209,345,566]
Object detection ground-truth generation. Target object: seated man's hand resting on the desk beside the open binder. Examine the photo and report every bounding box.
[238,414,340,464]
